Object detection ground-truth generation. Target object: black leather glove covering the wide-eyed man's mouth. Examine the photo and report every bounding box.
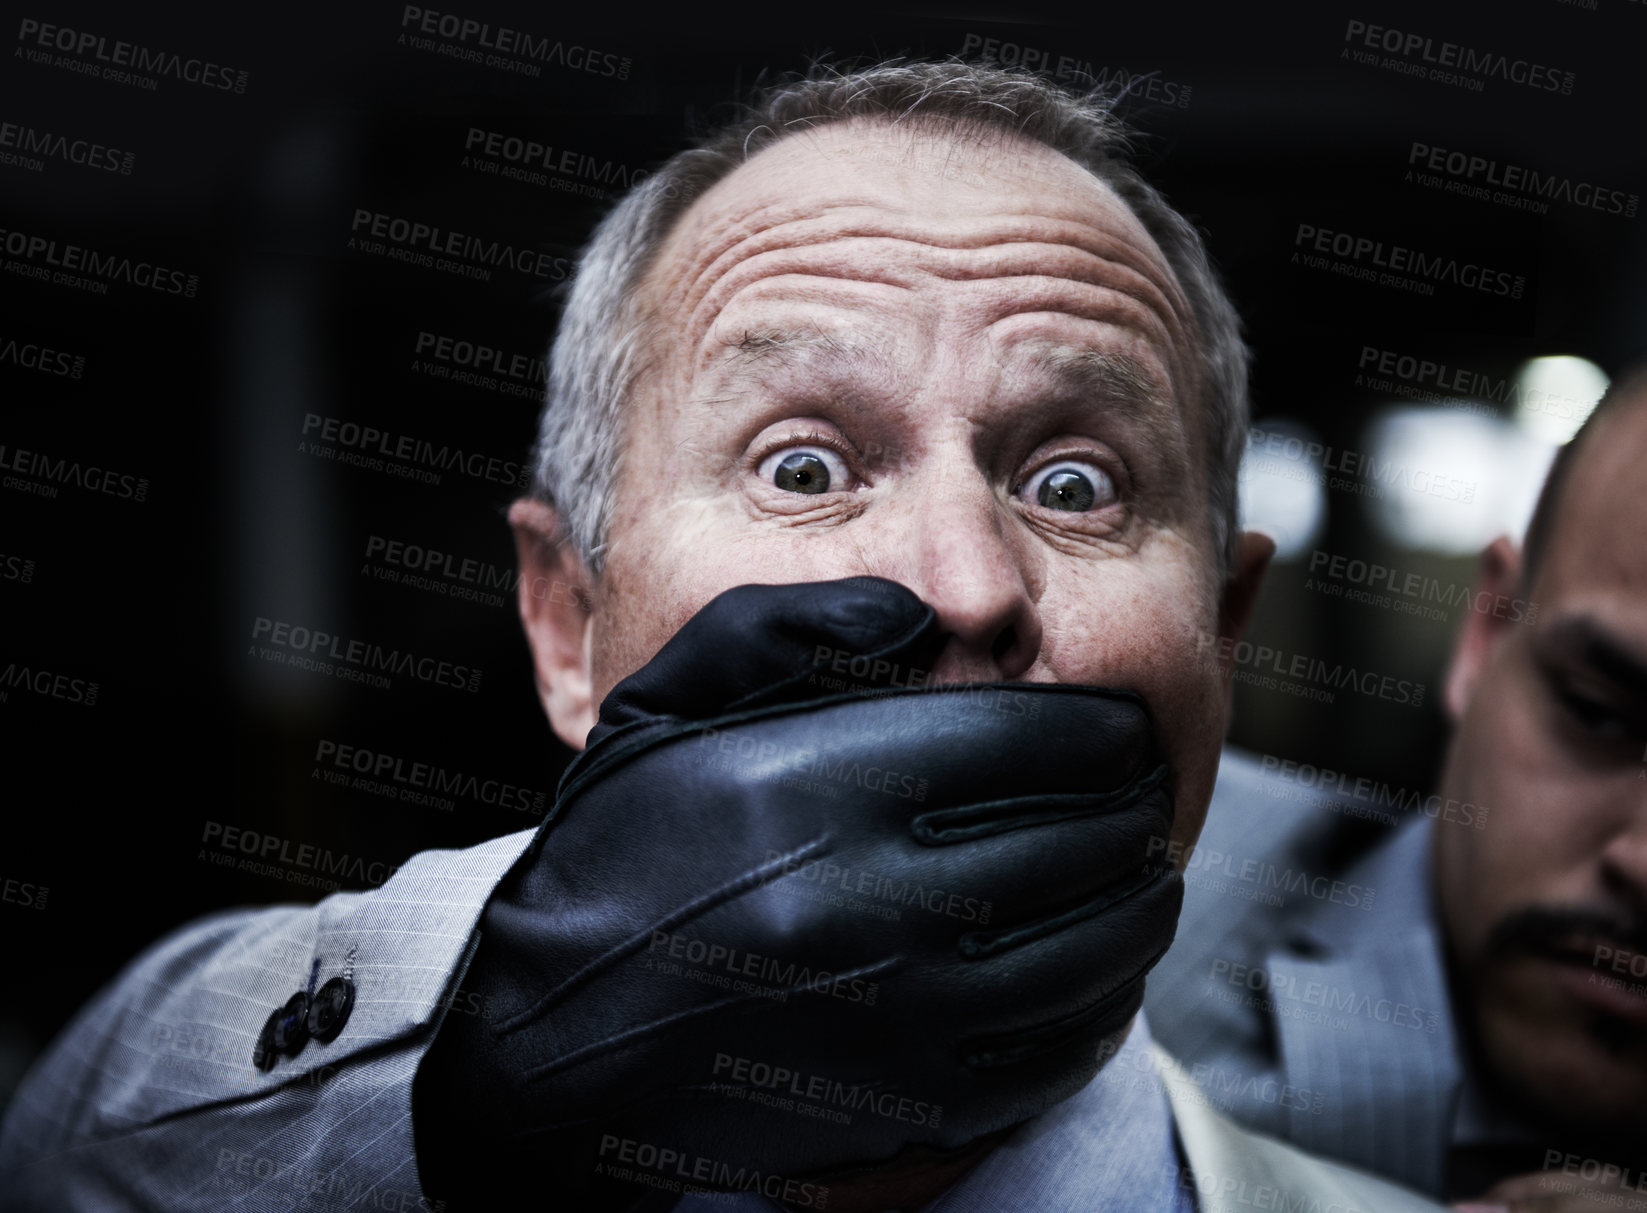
[417,578,1183,1208]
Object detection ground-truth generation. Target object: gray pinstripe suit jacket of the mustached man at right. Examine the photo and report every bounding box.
[1145,748,1463,1195]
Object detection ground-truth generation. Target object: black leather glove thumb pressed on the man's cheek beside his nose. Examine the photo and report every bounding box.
[588,577,940,745]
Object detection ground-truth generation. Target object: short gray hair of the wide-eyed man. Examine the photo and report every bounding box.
[532,59,1248,574]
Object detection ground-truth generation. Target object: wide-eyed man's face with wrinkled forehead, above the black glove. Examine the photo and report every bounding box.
[573,124,1263,842]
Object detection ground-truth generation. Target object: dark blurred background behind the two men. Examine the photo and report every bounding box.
[0,0,1647,1103]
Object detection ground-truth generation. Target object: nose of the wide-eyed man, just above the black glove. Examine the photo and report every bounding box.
[866,460,1044,682]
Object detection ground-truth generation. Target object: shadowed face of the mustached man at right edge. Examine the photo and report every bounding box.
[1436,400,1647,1147]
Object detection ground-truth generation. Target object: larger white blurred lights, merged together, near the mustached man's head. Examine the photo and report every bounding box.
[1362,356,1607,555]
